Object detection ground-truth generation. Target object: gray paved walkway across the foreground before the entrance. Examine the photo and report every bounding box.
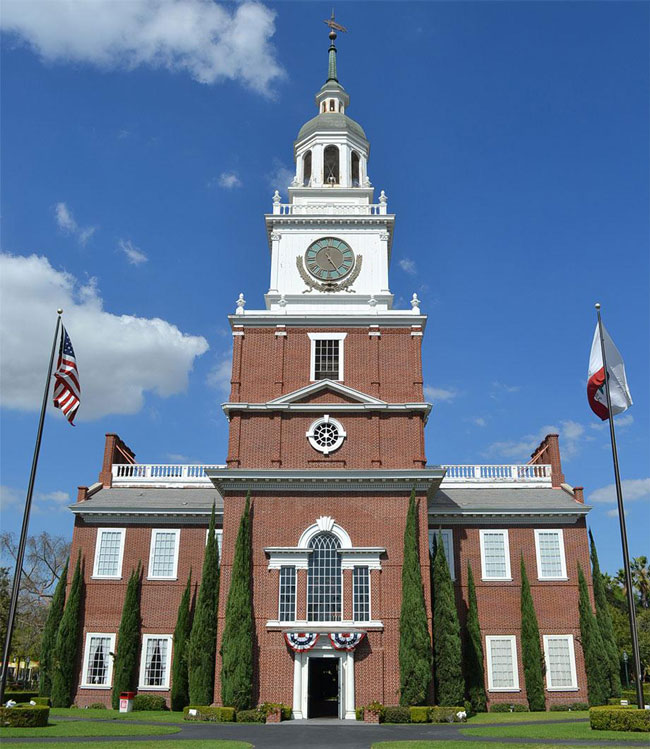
[2,718,648,749]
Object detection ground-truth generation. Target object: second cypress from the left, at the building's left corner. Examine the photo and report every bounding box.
[51,552,83,707]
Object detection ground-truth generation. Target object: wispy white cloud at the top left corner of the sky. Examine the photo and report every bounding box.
[1,0,284,95]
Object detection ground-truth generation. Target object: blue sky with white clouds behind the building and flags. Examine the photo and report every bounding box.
[0,0,650,571]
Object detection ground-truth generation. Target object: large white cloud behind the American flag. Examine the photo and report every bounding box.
[0,254,208,420]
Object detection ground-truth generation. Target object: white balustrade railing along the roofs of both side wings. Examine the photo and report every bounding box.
[112,463,551,487]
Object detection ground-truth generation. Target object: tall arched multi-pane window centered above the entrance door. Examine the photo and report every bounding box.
[307,533,341,622]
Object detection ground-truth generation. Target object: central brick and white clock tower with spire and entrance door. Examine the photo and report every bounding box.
[206,20,443,720]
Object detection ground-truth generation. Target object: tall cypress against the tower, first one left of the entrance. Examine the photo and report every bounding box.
[220,492,254,710]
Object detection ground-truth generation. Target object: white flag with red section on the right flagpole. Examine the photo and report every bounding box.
[587,325,632,421]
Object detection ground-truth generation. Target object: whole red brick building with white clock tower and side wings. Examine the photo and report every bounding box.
[67,30,589,719]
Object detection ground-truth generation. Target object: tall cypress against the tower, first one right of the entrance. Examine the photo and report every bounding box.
[399,490,432,705]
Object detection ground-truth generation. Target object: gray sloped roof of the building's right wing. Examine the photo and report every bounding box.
[429,488,590,515]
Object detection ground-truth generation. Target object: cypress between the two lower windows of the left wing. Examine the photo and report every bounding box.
[111,562,142,710]
